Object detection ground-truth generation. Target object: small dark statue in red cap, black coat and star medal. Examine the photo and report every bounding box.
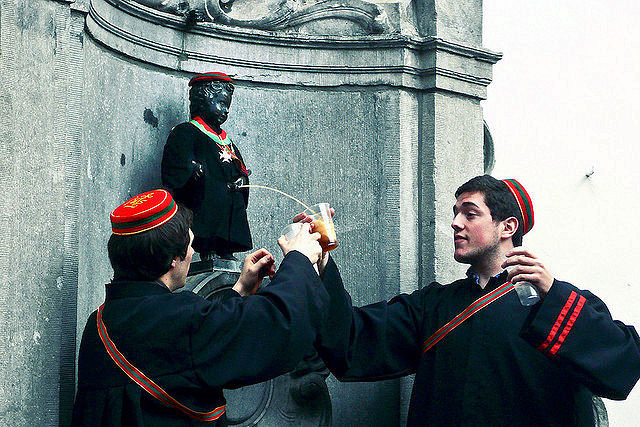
[162,73,253,259]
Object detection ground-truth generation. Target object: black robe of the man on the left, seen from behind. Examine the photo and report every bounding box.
[72,251,328,426]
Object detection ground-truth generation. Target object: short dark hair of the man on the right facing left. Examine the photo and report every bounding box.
[456,175,524,246]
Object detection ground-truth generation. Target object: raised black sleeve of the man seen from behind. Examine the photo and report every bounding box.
[191,251,328,388]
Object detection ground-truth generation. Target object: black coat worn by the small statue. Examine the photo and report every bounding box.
[162,122,253,253]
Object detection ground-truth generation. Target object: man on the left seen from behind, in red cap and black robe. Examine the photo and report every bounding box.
[72,190,328,426]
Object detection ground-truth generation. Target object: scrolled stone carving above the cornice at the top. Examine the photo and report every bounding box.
[132,0,389,35]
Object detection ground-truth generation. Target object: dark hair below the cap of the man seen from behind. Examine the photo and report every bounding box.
[108,206,192,280]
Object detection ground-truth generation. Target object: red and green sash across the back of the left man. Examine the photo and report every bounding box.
[98,304,226,421]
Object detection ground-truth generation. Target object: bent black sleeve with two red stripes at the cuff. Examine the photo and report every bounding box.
[520,280,640,400]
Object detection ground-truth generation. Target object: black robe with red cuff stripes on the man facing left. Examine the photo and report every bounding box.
[317,260,640,426]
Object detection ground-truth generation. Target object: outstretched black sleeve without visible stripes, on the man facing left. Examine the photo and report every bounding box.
[315,259,425,381]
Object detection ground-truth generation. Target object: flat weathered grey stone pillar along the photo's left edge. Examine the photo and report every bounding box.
[0,0,83,425]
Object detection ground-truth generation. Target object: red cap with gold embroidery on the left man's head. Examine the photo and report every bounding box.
[111,190,178,236]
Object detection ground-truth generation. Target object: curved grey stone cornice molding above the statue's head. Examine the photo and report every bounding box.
[87,0,501,99]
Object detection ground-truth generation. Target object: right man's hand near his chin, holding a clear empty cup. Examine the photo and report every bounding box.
[502,246,553,296]
